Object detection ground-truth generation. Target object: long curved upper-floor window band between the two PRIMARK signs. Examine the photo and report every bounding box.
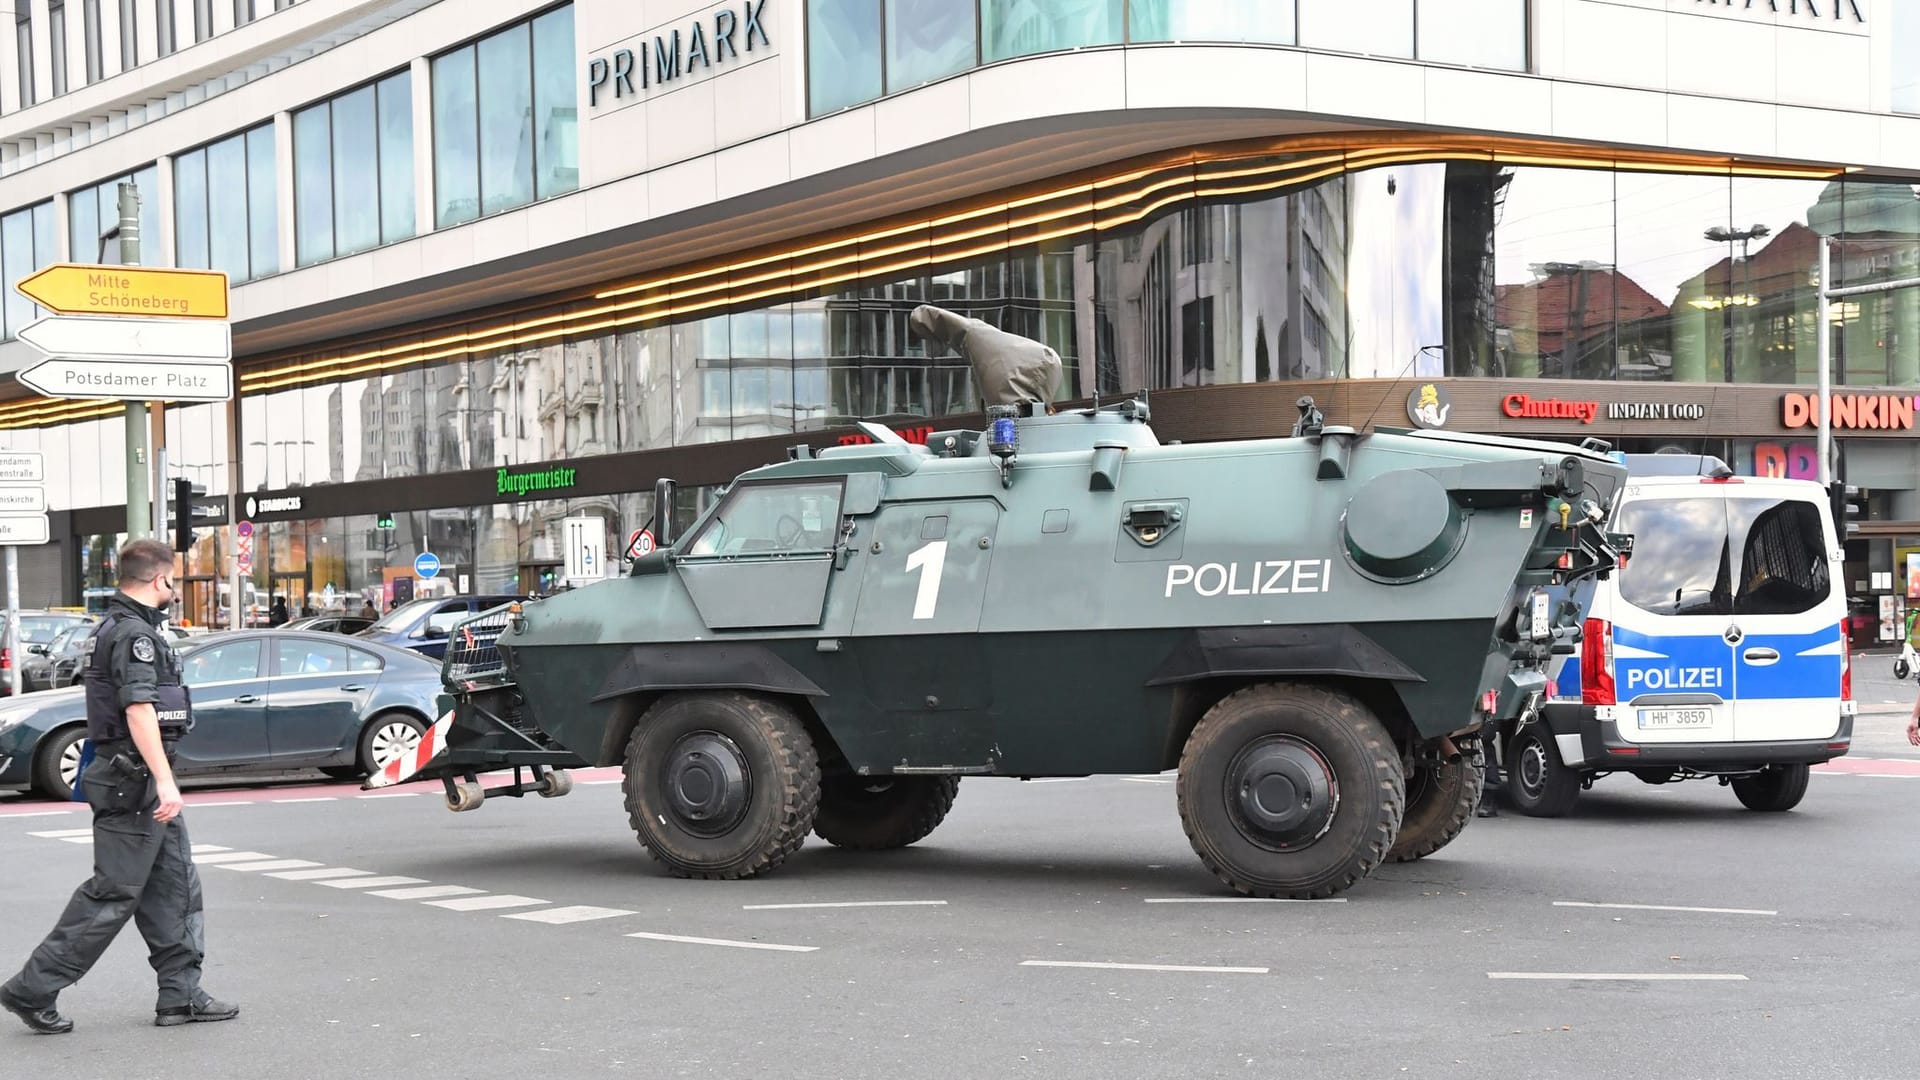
[806,0,1528,115]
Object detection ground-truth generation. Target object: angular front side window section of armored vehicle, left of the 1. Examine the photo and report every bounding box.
[674,477,845,630]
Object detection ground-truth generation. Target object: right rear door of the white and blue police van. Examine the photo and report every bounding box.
[1726,482,1847,742]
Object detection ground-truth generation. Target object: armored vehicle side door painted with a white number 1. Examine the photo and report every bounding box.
[849,500,1000,773]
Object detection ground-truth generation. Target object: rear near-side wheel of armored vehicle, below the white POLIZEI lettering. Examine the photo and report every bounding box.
[1175,682,1407,899]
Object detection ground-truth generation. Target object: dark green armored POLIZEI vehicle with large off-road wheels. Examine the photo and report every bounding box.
[382,309,1624,897]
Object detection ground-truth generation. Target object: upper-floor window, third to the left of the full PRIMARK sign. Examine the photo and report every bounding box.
[174,123,280,284]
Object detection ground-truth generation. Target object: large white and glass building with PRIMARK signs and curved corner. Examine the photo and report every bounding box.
[0,0,1920,621]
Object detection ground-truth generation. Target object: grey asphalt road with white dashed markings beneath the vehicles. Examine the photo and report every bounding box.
[0,699,1920,1080]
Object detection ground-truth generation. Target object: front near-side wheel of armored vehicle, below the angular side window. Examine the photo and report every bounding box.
[622,692,820,878]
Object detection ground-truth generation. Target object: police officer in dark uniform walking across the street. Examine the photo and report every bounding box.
[0,540,240,1034]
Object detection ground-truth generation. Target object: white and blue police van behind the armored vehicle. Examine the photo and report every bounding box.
[1500,454,1855,817]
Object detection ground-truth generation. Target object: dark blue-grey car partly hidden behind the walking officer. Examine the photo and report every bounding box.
[0,630,447,799]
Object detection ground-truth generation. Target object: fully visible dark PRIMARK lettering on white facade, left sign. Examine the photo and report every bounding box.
[588,0,774,108]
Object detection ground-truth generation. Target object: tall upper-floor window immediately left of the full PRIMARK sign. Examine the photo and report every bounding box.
[432,4,580,229]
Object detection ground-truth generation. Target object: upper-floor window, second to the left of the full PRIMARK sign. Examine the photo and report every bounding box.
[294,71,413,265]
